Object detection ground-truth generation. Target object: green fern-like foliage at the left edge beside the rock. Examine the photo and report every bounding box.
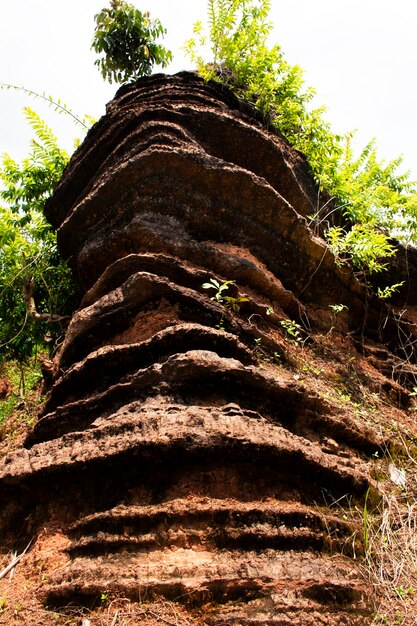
[0,108,75,361]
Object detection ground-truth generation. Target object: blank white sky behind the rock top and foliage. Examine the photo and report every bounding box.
[0,0,417,179]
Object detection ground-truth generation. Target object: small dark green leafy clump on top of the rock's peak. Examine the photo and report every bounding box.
[91,0,172,83]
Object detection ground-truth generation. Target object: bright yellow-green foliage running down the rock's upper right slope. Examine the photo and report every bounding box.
[185,0,417,272]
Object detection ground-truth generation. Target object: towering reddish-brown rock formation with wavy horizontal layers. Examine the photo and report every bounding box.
[0,74,414,626]
